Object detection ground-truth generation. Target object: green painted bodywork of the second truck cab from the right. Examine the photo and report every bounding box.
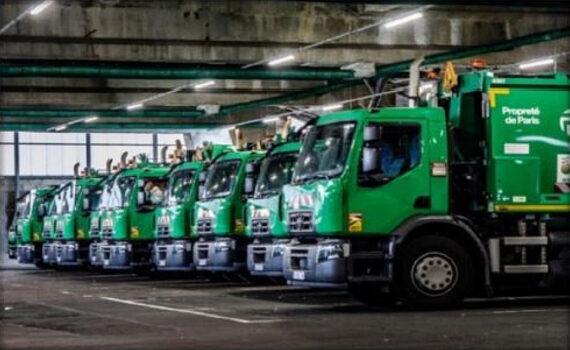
[246,142,301,238]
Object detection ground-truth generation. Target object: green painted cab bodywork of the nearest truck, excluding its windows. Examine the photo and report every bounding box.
[283,108,449,236]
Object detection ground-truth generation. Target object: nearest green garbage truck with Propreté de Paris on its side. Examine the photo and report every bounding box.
[283,70,570,307]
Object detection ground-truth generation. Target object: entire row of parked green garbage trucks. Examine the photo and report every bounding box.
[5,70,570,307]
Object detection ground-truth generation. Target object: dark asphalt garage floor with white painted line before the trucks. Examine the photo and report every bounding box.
[0,262,570,350]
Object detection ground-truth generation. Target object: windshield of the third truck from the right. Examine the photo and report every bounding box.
[204,160,240,199]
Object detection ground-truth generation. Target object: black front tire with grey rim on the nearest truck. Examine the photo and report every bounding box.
[395,235,474,308]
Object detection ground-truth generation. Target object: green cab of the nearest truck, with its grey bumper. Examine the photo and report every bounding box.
[283,108,440,287]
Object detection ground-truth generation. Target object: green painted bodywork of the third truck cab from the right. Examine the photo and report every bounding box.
[192,151,265,237]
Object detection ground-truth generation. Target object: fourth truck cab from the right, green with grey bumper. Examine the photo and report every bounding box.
[152,161,203,271]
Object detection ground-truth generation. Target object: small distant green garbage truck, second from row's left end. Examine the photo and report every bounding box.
[16,186,58,267]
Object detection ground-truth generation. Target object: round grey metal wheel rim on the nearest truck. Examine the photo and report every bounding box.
[411,252,457,296]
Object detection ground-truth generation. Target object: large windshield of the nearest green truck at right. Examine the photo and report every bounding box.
[294,122,355,181]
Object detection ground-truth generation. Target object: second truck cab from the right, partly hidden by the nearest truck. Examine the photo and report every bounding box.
[246,141,301,277]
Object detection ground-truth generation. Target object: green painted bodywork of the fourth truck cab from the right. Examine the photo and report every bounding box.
[155,162,202,239]
